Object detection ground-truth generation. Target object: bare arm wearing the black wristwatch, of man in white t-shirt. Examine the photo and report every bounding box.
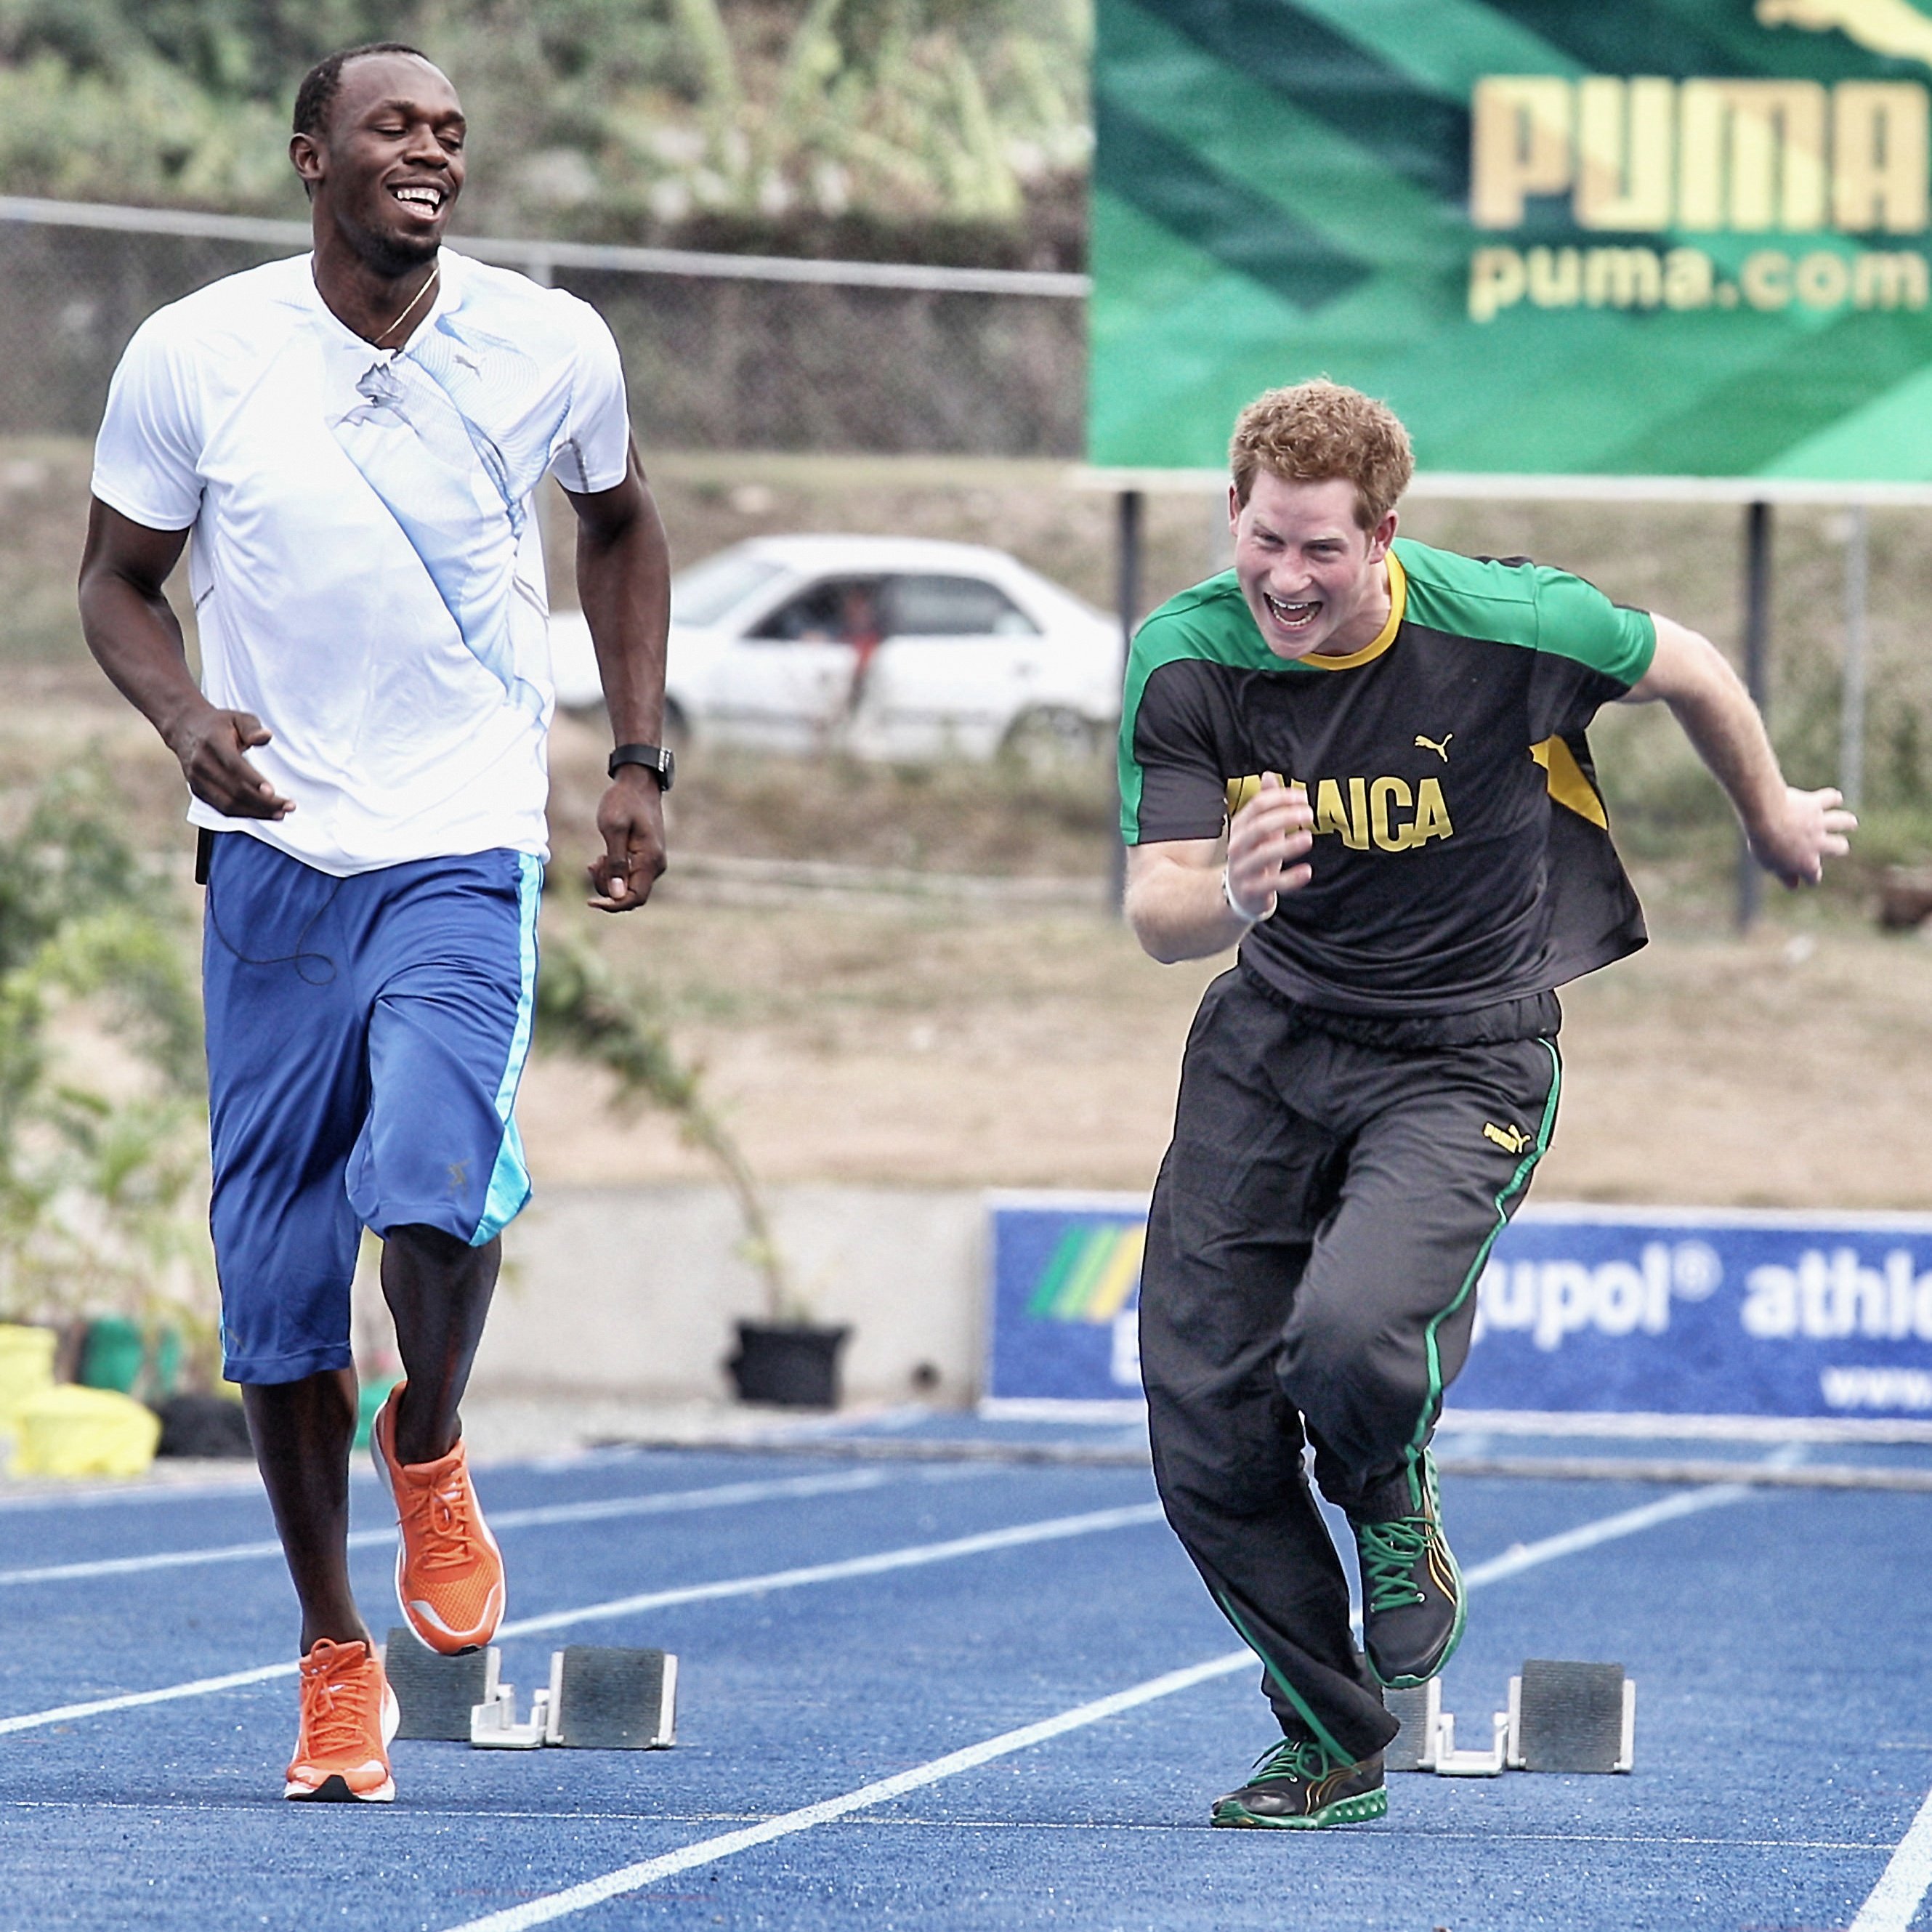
[566,448,671,912]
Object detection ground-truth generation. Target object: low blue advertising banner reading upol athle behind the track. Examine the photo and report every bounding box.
[985,1194,1932,1420]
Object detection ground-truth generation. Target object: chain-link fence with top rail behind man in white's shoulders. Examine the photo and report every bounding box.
[0,199,1086,456]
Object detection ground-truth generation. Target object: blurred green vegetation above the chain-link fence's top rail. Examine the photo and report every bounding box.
[0,0,1090,257]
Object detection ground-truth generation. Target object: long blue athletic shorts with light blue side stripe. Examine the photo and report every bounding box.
[201,833,541,1381]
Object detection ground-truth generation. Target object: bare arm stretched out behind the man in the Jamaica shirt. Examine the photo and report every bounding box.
[1625,616,1859,886]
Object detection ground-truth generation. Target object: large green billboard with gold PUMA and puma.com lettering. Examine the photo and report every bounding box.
[1088,0,1932,485]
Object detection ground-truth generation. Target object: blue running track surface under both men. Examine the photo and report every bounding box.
[0,1430,1932,1932]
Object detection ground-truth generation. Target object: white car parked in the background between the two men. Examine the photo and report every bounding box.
[551,537,1120,761]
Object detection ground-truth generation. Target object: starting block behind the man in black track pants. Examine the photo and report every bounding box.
[1381,1657,1636,1777]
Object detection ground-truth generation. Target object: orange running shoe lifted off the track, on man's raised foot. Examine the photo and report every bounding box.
[369,1381,502,1656]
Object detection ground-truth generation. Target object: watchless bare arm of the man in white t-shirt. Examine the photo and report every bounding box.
[81,498,296,819]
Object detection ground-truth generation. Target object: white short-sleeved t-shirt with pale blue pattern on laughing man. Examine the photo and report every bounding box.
[93,249,630,876]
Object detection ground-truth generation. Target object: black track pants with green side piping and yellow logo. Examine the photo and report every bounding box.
[1140,970,1559,1758]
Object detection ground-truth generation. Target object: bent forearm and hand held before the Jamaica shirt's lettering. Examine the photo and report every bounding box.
[1126,773,1314,966]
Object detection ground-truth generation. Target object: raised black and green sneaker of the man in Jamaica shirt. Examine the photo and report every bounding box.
[1349,1451,1468,1691]
